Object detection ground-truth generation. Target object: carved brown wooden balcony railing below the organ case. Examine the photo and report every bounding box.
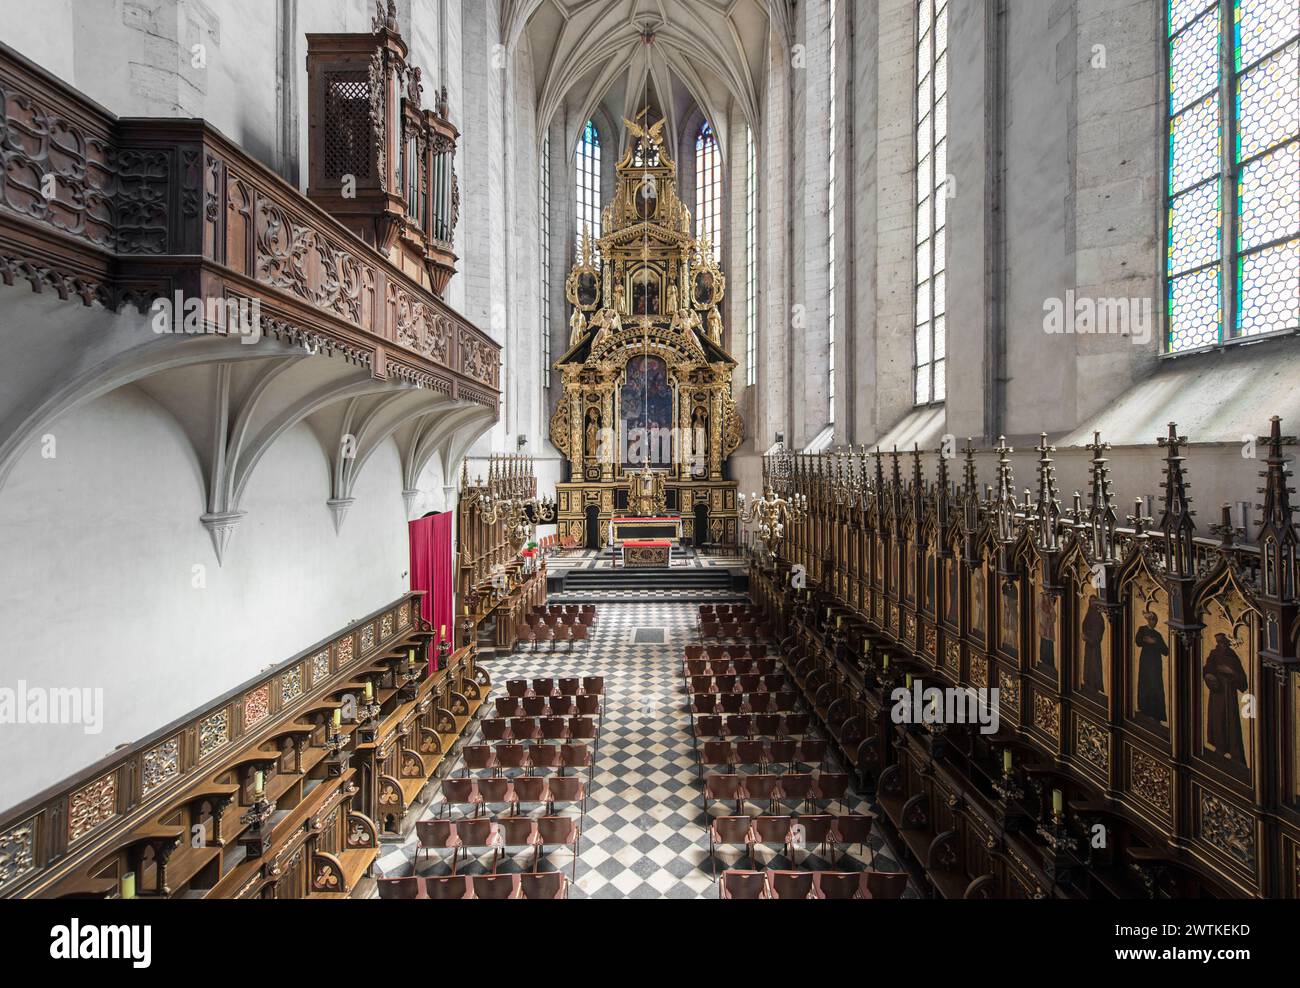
[0,44,501,408]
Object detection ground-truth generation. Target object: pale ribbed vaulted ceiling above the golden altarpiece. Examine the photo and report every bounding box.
[503,0,790,159]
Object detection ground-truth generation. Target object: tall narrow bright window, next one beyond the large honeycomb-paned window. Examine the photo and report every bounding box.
[914,0,949,406]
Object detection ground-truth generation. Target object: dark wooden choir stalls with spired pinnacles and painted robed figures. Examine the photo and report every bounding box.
[753,419,1300,898]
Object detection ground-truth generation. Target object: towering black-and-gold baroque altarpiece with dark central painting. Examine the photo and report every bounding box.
[550,118,744,547]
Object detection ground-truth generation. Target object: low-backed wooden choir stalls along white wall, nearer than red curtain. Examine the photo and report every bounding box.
[0,593,490,898]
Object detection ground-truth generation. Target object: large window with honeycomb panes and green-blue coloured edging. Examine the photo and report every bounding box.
[1165,0,1300,352]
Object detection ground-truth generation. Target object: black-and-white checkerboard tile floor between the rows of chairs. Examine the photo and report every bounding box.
[377,602,914,898]
